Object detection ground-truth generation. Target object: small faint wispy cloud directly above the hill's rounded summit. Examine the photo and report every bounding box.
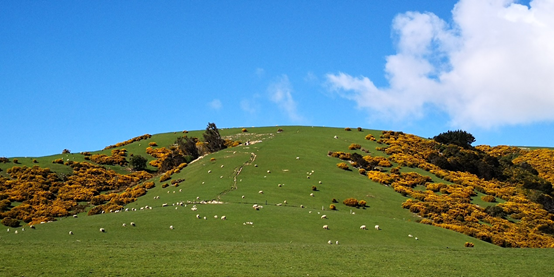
[267,75,303,122]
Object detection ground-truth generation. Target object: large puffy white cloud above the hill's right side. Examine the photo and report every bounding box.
[326,0,554,128]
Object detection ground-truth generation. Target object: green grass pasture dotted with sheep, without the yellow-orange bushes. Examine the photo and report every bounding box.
[0,126,554,276]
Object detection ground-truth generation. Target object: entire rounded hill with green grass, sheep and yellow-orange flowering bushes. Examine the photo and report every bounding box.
[0,126,554,275]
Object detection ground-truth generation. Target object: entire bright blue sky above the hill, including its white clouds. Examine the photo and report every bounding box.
[0,0,554,157]
